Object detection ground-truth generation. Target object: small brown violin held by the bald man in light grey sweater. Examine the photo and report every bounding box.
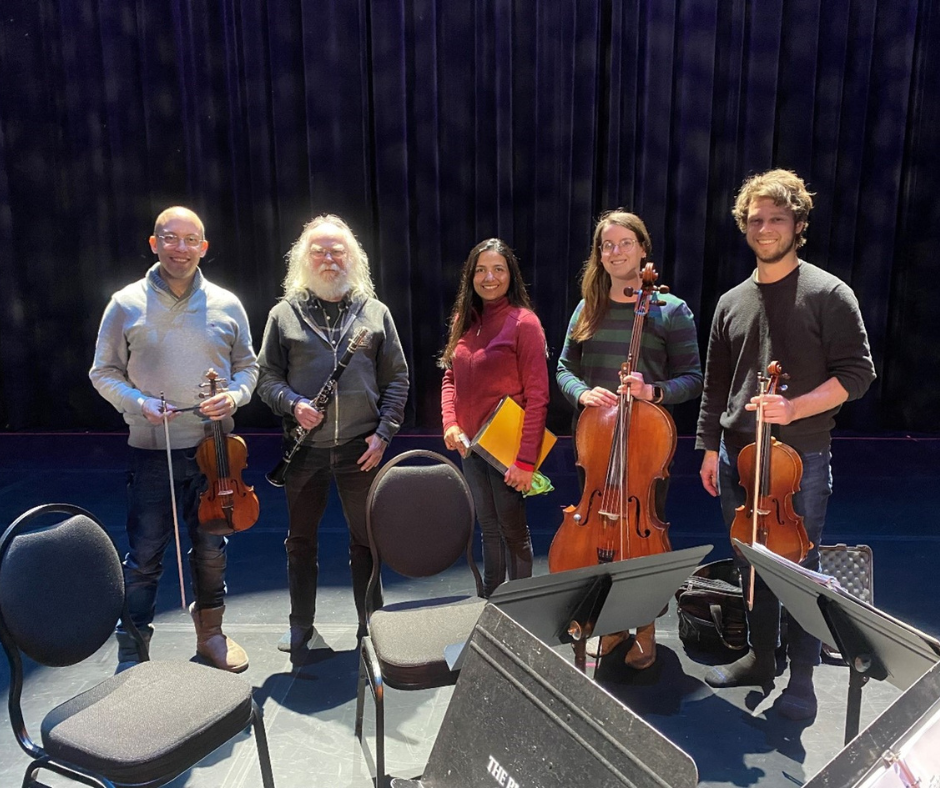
[196,369,259,536]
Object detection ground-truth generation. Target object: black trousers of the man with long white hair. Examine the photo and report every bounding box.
[284,436,382,627]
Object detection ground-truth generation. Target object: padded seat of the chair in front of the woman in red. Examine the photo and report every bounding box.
[369,597,486,689]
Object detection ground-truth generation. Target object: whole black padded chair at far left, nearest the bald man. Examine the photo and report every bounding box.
[0,504,274,788]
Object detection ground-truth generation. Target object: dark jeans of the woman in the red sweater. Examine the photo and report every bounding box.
[463,454,532,597]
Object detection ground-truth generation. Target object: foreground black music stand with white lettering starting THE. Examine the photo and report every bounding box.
[392,604,698,788]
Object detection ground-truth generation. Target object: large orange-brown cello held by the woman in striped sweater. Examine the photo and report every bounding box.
[548,263,676,572]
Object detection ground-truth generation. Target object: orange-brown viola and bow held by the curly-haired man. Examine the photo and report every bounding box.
[731,361,813,609]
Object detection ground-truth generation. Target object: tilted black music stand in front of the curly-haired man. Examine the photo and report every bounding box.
[732,539,940,744]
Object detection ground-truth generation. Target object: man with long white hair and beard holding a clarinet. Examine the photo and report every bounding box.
[258,215,408,653]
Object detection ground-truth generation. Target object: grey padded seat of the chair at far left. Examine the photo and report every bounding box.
[42,662,252,783]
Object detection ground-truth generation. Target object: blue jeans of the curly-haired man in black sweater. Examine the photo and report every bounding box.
[718,441,832,665]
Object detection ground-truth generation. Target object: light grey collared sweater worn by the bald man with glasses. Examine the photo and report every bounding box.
[89,264,258,449]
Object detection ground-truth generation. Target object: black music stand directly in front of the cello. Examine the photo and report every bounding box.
[478,545,712,672]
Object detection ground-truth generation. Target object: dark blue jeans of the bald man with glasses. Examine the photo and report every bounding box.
[117,447,227,637]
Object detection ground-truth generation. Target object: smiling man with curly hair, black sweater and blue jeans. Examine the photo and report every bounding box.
[695,170,875,720]
